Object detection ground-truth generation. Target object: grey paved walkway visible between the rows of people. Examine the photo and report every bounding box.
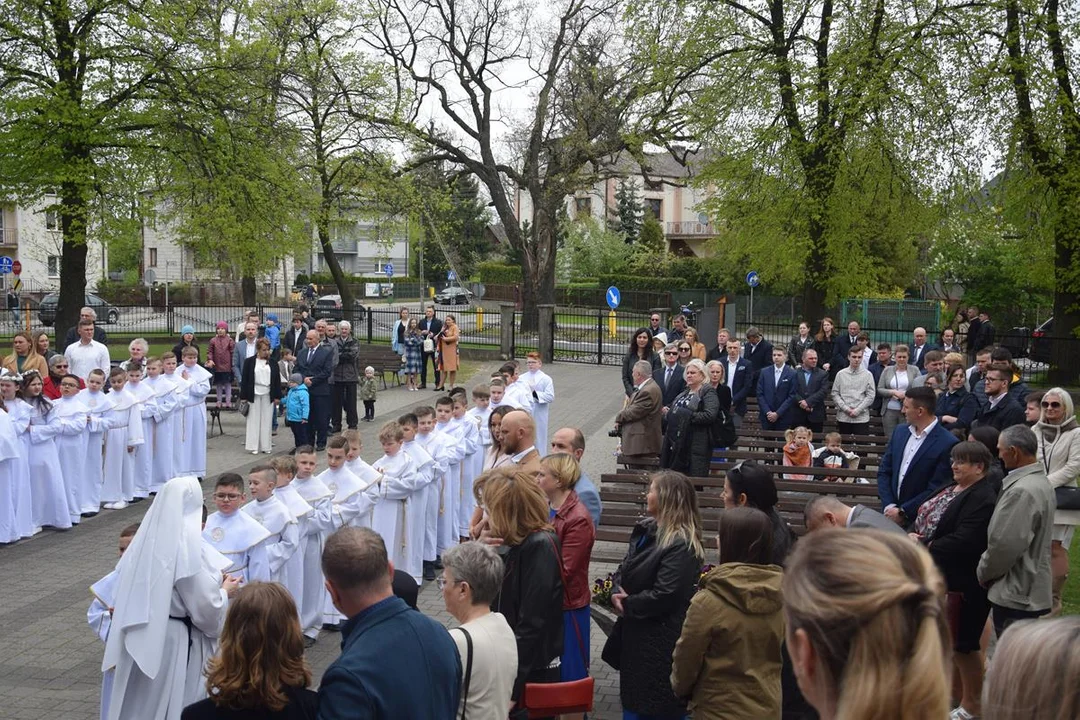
[0,364,622,720]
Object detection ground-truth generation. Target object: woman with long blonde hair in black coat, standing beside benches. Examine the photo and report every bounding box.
[603,471,705,718]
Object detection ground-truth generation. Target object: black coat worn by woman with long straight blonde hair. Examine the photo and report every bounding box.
[616,518,701,717]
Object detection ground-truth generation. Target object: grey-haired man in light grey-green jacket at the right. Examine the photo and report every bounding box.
[976,425,1056,637]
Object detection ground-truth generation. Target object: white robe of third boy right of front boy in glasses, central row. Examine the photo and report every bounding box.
[289,477,335,638]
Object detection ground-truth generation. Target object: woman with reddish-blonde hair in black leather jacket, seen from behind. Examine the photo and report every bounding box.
[480,468,563,718]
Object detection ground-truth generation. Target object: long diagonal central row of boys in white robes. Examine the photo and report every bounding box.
[79,356,554,719]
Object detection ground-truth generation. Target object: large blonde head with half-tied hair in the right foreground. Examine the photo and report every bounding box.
[783,529,950,720]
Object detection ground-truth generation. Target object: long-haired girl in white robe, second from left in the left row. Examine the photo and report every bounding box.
[23,372,71,531]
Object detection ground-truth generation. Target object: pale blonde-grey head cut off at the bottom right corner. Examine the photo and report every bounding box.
[983,615,1080,720]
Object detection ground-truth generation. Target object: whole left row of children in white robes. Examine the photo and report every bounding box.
[0,349,213,543]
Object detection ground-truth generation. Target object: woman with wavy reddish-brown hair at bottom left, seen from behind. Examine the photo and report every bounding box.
[181,583,319,720]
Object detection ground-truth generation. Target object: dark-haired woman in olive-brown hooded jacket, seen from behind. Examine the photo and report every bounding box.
[672,507,784,720]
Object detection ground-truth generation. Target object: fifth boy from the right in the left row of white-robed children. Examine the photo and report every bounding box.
[102,367,143,510]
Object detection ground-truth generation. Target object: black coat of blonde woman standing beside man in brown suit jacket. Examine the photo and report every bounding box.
[660,382,720,477]
